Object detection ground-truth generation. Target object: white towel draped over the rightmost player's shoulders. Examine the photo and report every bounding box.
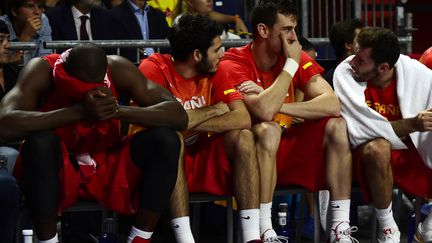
[333,55,432,169]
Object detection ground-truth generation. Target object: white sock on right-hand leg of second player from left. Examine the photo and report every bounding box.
[239,209,260,242]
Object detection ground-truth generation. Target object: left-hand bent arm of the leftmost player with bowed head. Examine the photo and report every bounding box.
[0,58,84,141]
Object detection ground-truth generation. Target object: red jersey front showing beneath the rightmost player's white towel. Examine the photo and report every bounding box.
[364,76,402,121]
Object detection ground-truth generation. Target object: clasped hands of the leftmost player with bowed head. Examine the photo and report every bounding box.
[82,87,119,120]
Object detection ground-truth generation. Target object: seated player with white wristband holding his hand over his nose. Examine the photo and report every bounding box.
[219,0,355,242]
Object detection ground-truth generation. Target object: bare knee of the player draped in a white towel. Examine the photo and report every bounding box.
[361,138,391,168]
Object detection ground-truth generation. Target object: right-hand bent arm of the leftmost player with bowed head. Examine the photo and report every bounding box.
[108,56,188,130]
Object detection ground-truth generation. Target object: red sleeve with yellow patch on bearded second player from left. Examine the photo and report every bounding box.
[211,70,243,104]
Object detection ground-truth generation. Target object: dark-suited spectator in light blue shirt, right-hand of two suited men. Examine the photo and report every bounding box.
[111,0,169,62]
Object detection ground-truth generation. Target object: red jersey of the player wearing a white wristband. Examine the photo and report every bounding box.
[219,43,324,127]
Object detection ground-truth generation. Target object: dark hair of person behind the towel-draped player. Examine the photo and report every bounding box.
[329,19,365,60]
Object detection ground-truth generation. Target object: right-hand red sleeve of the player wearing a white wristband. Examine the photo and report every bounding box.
[294,51,324,91]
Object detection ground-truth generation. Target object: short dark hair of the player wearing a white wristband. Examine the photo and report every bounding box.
[251,0,298,37]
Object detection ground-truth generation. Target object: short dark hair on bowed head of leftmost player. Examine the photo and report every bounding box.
[64,43,107,83]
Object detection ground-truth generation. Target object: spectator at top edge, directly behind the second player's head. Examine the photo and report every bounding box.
[173,0,247,39]
